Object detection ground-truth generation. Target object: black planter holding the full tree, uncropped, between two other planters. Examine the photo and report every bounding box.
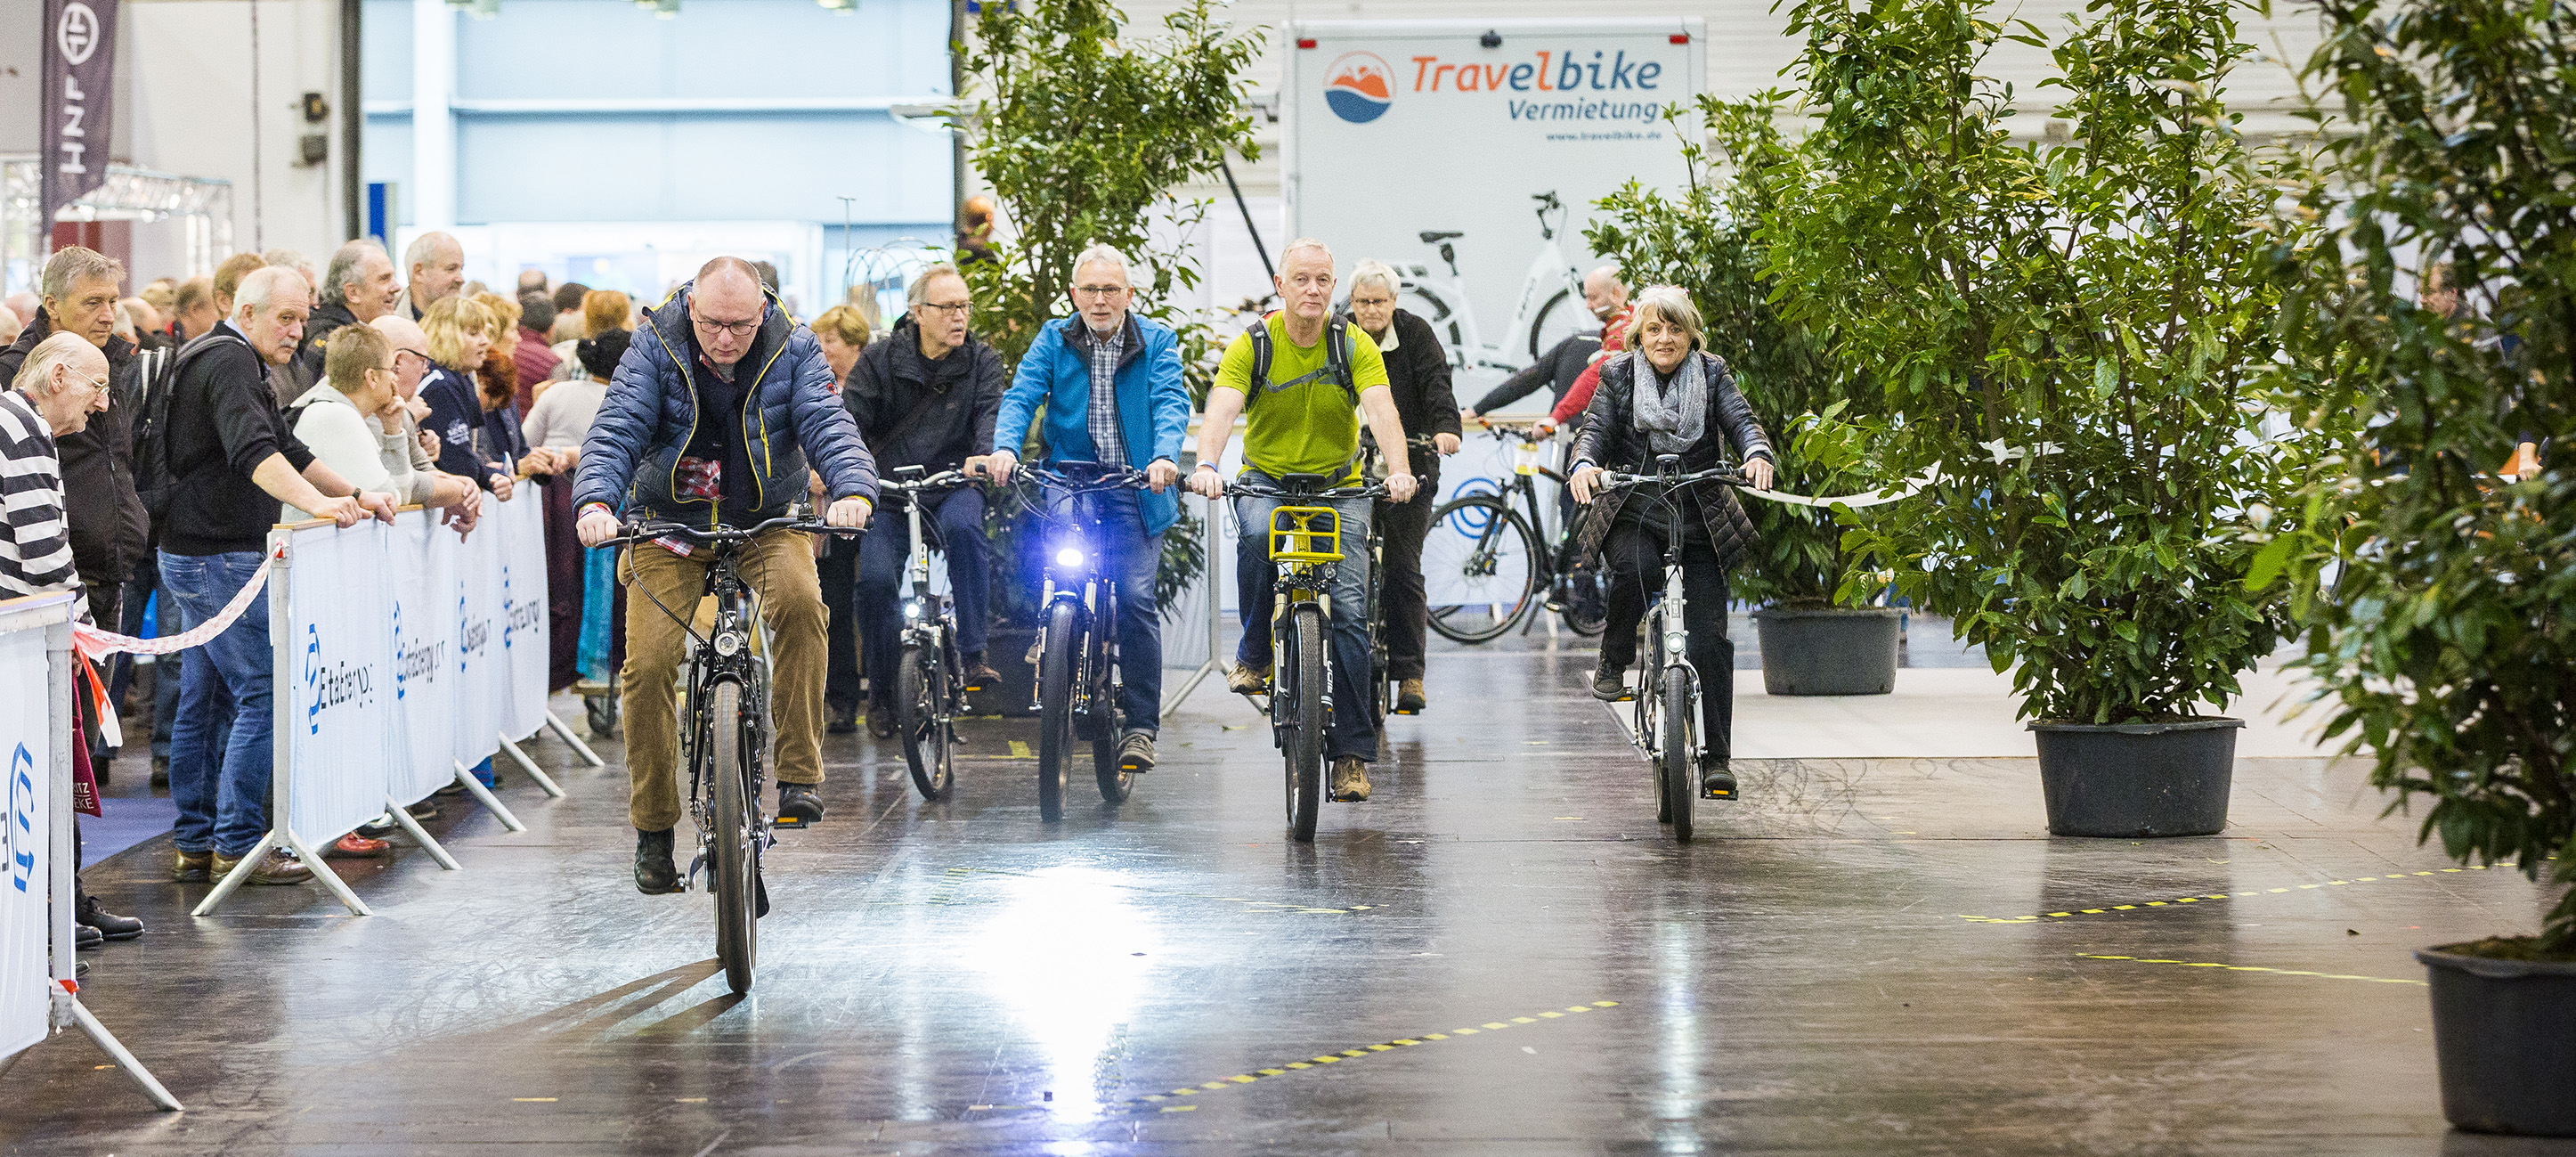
[2030,719,2247,837]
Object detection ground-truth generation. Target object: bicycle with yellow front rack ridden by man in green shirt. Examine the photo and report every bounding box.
[1226,474,1386,843]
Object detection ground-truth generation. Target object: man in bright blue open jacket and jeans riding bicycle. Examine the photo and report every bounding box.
[966,245,1190,770]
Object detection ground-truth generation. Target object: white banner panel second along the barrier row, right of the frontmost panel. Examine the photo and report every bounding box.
[384,513,456,804]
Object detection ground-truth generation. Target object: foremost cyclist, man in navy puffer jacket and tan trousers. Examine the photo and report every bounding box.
[572,257,876,894]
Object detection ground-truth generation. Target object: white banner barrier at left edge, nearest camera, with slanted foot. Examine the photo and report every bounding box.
[0,592,181,1111]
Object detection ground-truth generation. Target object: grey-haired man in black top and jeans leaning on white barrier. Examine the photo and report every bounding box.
[152,268,394,884]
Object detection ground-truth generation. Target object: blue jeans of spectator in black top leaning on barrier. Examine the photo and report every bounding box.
[159,551,276,858]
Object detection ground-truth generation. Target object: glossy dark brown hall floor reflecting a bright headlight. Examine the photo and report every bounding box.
[0,644,2576,1157]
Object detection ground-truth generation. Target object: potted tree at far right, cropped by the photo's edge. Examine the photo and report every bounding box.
[2249,0,2576,1137]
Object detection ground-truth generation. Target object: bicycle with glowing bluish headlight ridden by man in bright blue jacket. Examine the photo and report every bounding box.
[1020,461,1149,822]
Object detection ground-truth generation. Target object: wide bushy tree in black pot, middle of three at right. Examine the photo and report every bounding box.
[1757,0,2300,837]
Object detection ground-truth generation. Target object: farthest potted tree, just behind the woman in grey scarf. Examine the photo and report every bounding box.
[1587,95,1898,696]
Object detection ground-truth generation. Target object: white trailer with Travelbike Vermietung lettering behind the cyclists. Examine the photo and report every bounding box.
[1280,15,1705,399]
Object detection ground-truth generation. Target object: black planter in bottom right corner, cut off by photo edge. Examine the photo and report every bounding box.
[2417,946,2576,1137]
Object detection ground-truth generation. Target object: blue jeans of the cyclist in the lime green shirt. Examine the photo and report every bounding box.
[1234,469,1378,762]
